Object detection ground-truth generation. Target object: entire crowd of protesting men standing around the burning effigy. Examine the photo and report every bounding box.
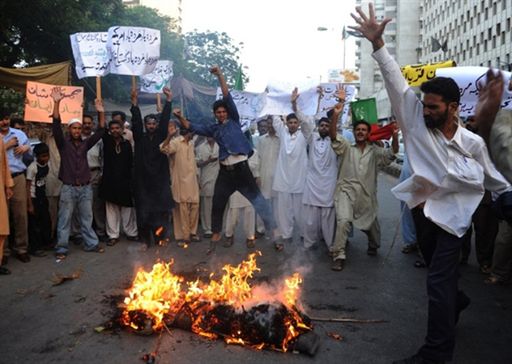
[0,4,512,363]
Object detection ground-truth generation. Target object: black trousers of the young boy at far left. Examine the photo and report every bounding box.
[28,198,52,253]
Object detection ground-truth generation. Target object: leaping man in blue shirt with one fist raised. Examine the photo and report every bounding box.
[174,66,276,252]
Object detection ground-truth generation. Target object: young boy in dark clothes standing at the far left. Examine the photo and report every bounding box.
[27,143,52,257]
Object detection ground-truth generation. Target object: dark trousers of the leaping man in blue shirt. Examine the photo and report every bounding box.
[212,161,276,233]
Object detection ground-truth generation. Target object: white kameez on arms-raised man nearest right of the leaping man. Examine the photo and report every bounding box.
[272,116,312,193]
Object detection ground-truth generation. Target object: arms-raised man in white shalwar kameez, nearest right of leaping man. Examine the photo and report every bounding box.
[272,89,313,250]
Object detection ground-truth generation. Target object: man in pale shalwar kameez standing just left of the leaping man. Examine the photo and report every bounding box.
[196,138,219,238]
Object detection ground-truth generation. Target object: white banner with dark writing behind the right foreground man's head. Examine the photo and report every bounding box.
[436,67,512,117]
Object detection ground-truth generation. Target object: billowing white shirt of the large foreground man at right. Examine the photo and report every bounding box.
[373,47,511,237]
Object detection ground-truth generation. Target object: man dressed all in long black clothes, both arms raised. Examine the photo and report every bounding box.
[130,87,174,247]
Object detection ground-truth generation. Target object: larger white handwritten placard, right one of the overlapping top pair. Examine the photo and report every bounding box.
[107,26,161,76]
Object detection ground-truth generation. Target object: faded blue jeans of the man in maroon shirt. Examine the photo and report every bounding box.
[56,185,98,254]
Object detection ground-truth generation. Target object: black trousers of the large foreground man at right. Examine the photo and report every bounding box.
[412,208,466,361]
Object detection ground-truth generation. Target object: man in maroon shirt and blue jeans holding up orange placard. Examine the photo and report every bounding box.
[51,87,105,259]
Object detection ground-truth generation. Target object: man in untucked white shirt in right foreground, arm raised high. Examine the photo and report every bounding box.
[351,3,510,363]
